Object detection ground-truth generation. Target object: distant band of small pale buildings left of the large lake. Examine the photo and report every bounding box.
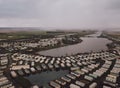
[0,38,61,47]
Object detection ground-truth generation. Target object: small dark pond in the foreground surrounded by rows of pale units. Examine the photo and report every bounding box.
[25,70,69,88]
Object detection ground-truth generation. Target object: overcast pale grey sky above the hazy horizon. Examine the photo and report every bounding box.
[0,0,120,29]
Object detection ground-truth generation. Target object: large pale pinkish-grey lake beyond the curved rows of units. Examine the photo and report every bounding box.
[38,32,112,56]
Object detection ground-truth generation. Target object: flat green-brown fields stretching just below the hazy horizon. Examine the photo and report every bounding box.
[0,31,94,39]
